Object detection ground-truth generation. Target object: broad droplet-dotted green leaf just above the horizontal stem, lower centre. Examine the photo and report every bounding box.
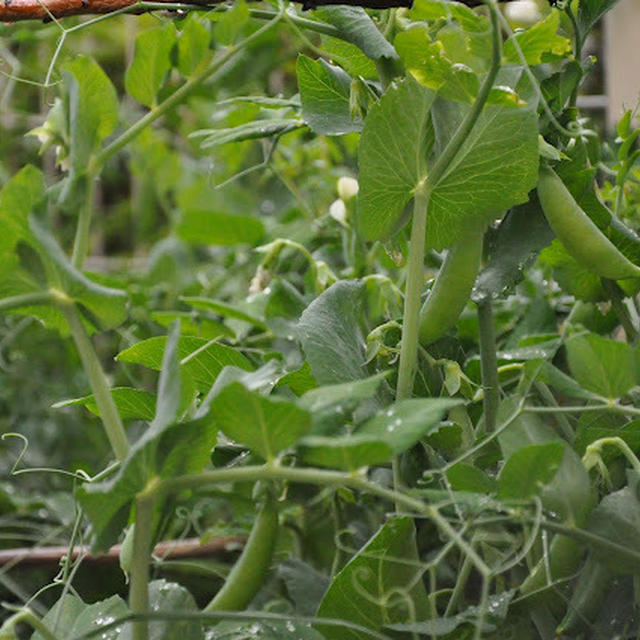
[211,382,311,460]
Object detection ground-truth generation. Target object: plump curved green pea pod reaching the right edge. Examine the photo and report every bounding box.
[538,166,640,280]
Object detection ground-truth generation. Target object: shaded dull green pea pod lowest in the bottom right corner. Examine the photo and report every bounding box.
[557,553,613,635]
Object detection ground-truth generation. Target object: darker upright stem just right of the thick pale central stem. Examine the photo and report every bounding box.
[478,298,500,433]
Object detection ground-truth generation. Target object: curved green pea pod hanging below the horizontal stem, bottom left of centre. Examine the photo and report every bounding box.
[205,495,278,613]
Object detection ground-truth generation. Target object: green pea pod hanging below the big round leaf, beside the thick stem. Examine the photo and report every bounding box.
[420,232,484,346]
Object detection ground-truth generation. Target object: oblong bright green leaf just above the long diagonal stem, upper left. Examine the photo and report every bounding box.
[124,22,176,107]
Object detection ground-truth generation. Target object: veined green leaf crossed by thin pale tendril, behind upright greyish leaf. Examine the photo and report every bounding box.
[116,336,253,393]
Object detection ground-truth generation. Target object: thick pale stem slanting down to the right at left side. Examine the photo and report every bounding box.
[57,293,129,462]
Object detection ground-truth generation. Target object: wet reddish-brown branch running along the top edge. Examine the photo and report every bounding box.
[0,0,413,22]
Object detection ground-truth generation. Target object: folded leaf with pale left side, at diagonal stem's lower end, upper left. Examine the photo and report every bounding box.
[63,56,118,174]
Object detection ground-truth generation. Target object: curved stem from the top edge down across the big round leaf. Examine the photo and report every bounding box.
[425,0,502,189]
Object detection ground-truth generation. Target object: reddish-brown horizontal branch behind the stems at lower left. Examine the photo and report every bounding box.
[0,536,246,566]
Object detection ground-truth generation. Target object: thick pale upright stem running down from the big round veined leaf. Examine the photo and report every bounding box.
[396,185,429,401]
